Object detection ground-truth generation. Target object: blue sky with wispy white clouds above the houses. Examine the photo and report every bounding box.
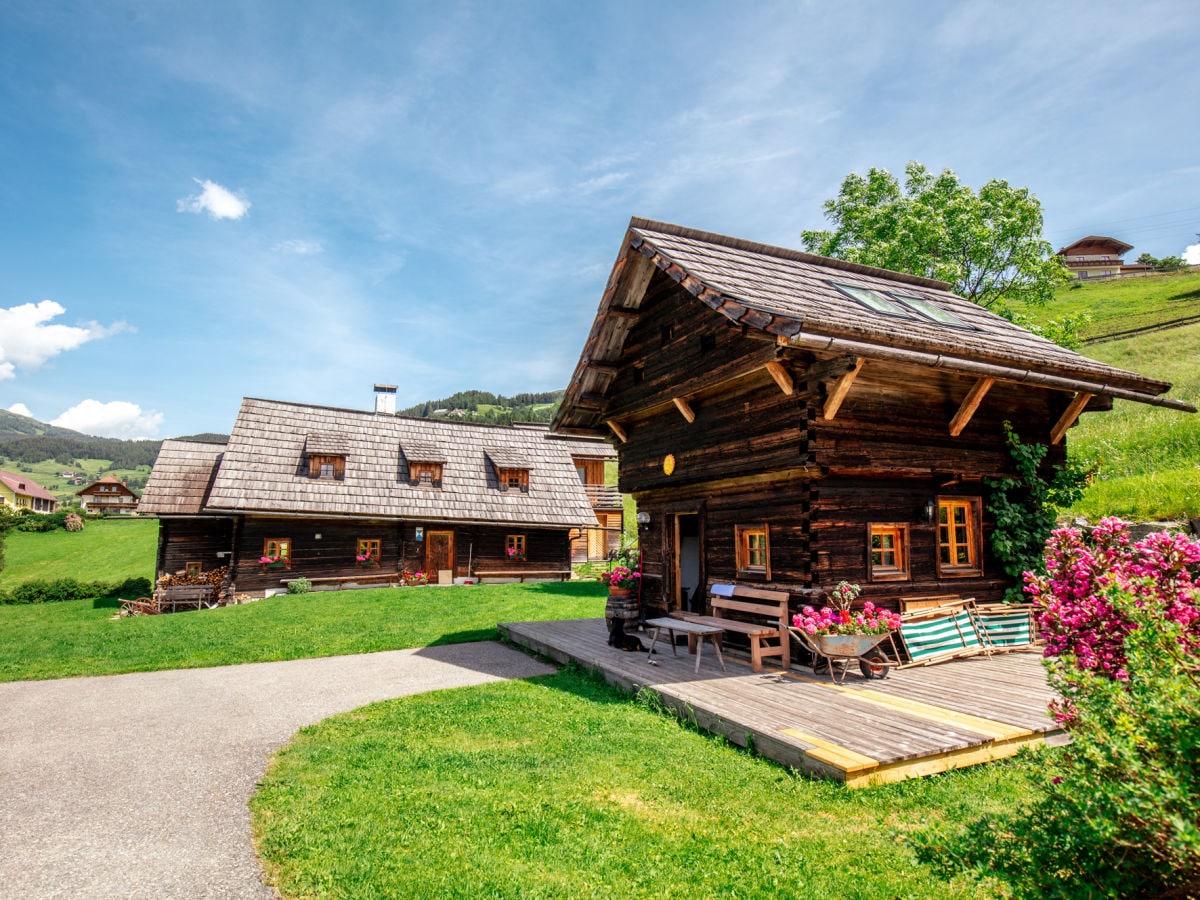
[0,0,1200,438]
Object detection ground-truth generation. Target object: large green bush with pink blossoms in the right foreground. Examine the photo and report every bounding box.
[917,520,1200,896]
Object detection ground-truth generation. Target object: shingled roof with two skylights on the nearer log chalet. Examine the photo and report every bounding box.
[553,218,1195,431]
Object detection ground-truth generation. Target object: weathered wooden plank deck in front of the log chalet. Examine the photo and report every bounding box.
[499,619,1066,787]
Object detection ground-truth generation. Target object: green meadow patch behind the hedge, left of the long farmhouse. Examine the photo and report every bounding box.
[0,518,158,588]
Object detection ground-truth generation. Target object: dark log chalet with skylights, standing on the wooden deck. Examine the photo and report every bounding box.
[553,218,1195,611]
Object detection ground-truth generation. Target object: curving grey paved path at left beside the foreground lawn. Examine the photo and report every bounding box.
[0,642,553,900]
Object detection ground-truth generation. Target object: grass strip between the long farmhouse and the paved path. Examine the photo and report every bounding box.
[0,581,605,682]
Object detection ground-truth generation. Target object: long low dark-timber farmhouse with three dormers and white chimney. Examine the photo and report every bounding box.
[142,398,620,593]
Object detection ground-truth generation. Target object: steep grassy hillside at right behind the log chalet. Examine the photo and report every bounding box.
[1021,272,1200,521]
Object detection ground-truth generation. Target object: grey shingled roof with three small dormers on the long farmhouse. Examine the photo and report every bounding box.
[201,397,614,528]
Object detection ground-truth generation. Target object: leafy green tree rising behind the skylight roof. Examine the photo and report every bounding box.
[802,162,1068,307]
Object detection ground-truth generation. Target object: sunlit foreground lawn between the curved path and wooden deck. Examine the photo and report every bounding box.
[251,668,1033,898]
